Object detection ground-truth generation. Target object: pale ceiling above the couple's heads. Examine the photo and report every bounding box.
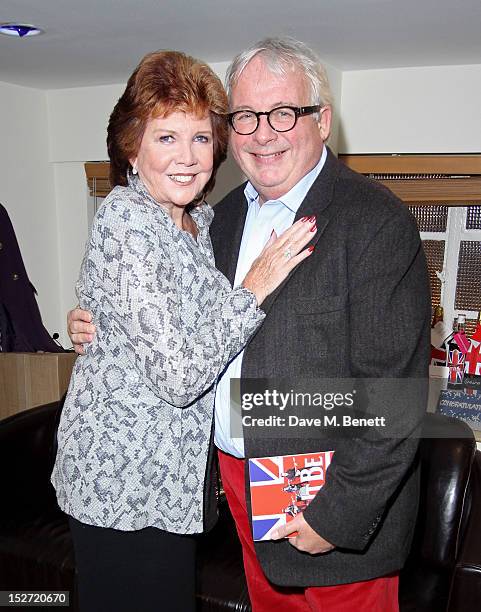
[0,0,481,89]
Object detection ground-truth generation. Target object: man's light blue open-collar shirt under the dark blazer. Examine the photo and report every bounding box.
[214,147,327,458]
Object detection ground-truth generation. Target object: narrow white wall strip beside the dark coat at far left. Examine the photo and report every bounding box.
[0,83,60,340]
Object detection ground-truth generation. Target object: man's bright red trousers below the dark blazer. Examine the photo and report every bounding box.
[219,451,399,612]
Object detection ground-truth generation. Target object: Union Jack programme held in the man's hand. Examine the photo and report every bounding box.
[249,451,334,541]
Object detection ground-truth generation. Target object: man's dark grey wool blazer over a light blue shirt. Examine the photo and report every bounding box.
[211,151,430,586]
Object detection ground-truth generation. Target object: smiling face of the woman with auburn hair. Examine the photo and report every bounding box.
[130,112,214,208]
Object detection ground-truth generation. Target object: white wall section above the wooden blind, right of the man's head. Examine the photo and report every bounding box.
[339,64,481,153]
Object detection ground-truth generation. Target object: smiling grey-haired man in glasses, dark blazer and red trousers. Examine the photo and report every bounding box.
[69,39,430,612]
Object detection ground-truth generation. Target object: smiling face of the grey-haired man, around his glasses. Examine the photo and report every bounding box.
[230,56,331,202]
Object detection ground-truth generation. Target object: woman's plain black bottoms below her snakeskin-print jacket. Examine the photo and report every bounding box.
[70,517,195,612]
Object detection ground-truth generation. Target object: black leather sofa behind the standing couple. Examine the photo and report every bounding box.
[0,404,481,612]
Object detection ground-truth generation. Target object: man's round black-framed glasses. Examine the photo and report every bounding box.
[227,104,322,136]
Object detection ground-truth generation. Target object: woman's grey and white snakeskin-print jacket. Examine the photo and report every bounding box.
[52,175,265,533]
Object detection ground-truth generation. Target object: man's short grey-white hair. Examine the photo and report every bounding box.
[225,37,332,106]
